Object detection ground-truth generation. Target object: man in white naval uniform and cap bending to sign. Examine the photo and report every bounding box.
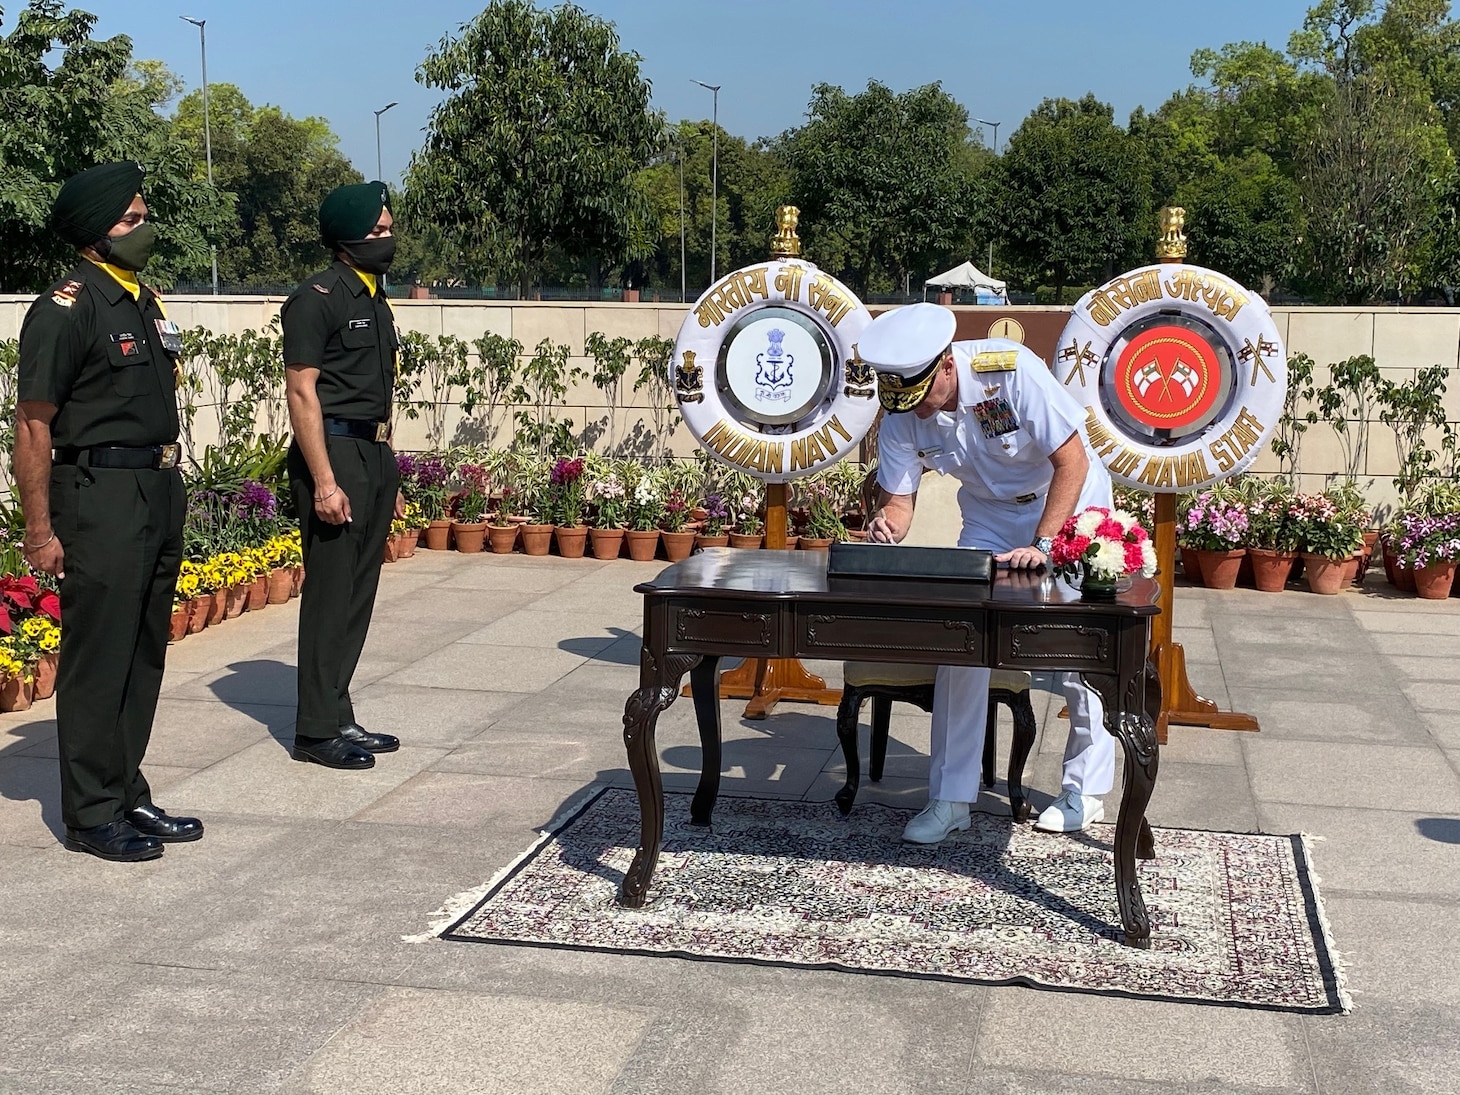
[858,304,1115,844]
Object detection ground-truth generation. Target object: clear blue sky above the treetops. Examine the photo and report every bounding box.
[77,0,1308,183]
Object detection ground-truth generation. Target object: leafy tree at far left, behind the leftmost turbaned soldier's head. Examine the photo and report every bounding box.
[0,0,229,292]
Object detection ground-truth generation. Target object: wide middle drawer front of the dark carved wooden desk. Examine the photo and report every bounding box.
[796,604,988,666]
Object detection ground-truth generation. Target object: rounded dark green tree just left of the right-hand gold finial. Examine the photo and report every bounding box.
[994,95,1155,302]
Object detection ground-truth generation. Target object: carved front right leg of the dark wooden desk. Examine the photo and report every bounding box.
[1083,659,1161,949]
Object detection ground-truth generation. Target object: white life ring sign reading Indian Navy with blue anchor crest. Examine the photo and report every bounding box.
[669,258,877,483]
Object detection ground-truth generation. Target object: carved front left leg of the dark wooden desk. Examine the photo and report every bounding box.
[619,648,699,908]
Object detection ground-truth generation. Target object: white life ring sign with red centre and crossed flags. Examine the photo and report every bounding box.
[1054,263,1288,493]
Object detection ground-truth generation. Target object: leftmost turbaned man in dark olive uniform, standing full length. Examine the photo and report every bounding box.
[15,164,203,861]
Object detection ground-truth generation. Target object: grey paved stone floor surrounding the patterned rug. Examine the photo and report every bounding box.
[0,552,1460,1095]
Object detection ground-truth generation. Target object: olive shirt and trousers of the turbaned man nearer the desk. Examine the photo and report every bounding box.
[282,261,400,739]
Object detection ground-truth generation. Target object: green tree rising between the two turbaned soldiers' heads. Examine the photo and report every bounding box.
[172,83,362,285]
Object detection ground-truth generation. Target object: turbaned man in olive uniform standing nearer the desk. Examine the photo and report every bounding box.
[283,183,404,768]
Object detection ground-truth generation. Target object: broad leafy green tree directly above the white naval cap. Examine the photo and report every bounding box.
[762,80,988,293]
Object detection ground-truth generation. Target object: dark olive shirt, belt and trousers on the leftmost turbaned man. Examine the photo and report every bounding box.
[18,261,185,829]
